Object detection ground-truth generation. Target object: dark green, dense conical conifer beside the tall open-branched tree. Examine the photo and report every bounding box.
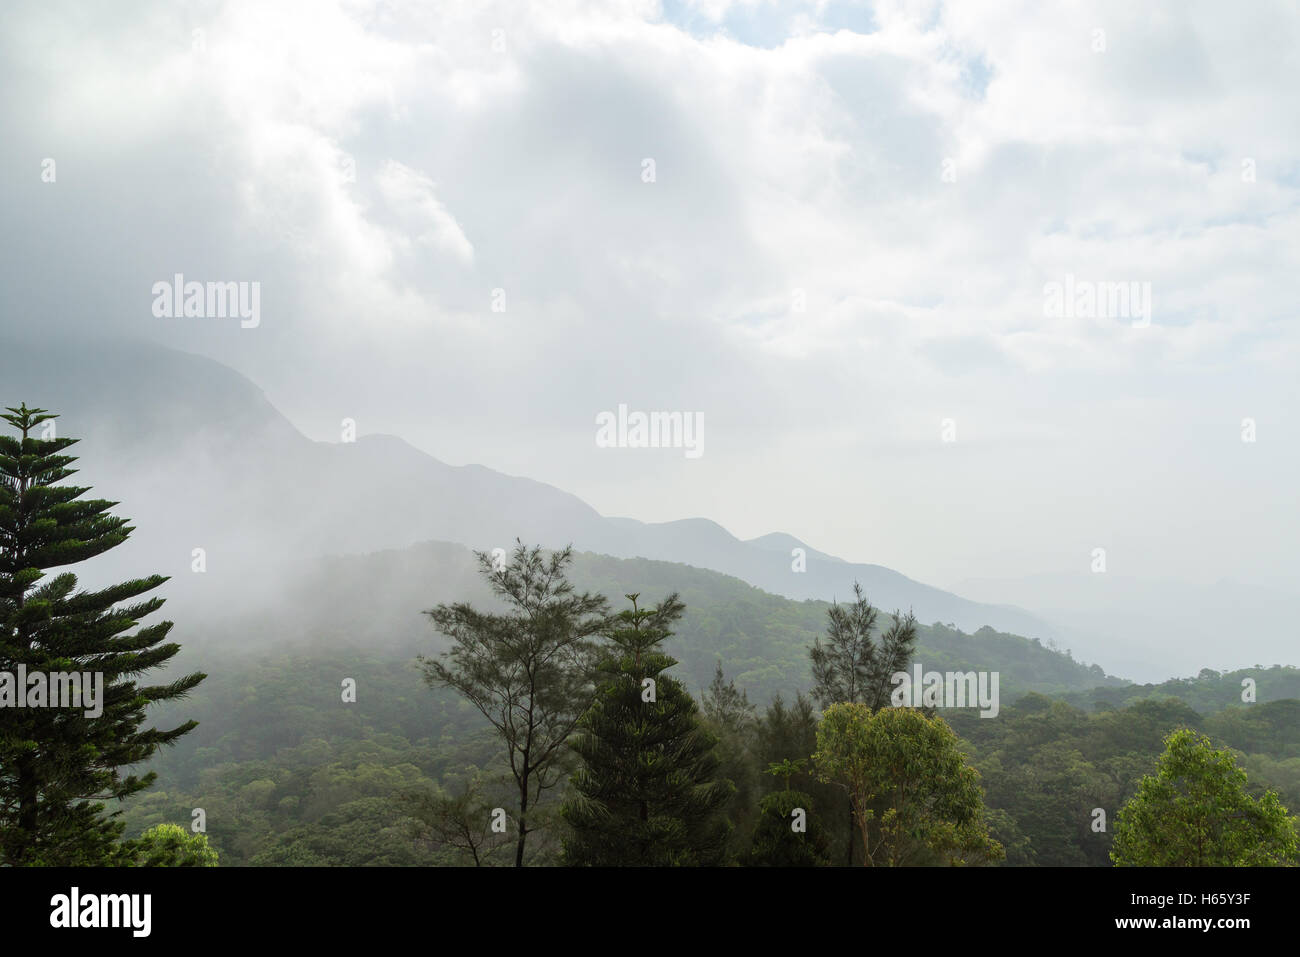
[562,594,732,867]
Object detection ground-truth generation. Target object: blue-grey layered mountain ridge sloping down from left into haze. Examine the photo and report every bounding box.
[0,339,1054,638]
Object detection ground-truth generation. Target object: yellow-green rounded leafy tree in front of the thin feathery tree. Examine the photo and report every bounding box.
[814,702,1005,866]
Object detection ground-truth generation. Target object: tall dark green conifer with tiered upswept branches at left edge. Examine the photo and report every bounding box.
[0,406,204,866]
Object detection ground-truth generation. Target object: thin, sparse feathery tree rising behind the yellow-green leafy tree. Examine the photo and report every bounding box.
[809,581,917,867]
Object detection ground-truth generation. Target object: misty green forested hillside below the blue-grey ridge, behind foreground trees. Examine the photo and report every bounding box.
[116,544,1300,866]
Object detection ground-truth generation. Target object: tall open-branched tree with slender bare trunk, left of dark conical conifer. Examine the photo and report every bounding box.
[420,542,608,867]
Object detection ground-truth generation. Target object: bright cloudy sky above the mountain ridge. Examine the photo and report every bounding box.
[0,0,1300,599]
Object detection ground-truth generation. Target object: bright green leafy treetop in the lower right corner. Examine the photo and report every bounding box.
[1110,728,1300,867]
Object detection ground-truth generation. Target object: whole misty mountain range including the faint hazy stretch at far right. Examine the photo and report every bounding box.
[0,338,1295,680]
